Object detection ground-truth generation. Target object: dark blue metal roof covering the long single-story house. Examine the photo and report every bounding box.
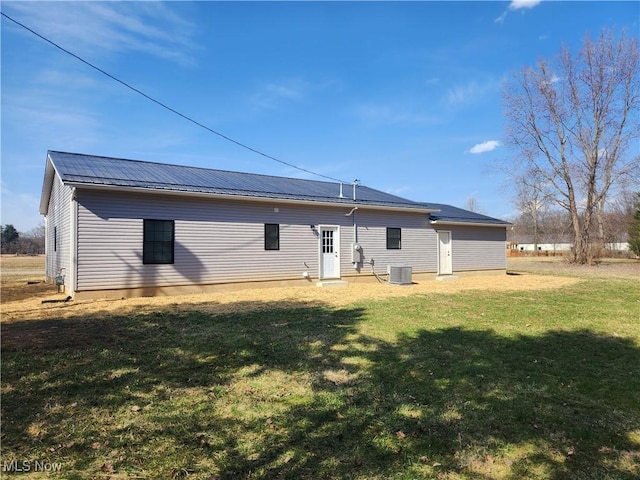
[40,151,507,225]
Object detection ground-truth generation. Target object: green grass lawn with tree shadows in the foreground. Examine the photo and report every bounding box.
[2,278,640,480]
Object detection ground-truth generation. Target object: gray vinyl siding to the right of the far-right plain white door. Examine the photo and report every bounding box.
[450,226,507,272]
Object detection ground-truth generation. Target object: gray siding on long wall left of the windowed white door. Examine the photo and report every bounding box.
[78,192,317,290]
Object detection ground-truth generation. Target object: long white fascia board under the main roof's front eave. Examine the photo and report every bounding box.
[65,181,440,214]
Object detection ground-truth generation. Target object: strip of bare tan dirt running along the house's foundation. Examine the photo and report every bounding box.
[2,274,580,322]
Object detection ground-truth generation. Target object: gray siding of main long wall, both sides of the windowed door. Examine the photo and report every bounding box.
[72,190,436,291]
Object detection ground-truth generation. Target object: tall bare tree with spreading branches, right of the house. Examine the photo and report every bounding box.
[503,30,640,263]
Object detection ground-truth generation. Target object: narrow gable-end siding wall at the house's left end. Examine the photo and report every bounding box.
[45,175,73,287]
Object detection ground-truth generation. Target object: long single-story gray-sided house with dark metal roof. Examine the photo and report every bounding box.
[40,151,510,298]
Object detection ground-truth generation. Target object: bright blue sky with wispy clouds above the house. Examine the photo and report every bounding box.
[1,0,640,231]
